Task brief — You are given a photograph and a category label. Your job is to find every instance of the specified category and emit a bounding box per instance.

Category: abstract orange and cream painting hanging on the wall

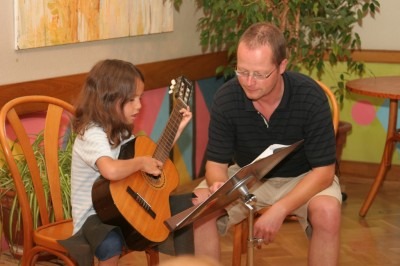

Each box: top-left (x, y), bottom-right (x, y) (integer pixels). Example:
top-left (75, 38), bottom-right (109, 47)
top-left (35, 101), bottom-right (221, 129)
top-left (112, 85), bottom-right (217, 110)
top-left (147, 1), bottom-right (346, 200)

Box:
top-left (14, 0), bottom-right (173, 50)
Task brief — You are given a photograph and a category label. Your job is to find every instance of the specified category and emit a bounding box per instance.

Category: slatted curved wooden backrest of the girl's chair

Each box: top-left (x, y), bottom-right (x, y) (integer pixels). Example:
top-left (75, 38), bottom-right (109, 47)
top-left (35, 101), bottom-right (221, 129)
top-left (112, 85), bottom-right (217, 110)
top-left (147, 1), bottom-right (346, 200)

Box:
top-left (0, 96), bottom-right (75, 254)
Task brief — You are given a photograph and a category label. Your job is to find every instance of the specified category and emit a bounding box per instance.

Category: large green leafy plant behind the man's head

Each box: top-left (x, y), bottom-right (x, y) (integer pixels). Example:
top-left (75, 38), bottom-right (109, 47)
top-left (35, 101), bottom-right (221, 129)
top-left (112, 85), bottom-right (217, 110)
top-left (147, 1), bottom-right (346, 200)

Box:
top-left (174, 0), bottom-right (380, 108)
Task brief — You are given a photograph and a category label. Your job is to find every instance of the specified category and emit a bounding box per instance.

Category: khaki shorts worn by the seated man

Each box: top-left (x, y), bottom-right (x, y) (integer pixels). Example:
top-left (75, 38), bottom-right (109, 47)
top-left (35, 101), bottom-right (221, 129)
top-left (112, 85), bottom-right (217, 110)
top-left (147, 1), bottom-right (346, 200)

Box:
top-left (197, 165), bottom-right (342, 236)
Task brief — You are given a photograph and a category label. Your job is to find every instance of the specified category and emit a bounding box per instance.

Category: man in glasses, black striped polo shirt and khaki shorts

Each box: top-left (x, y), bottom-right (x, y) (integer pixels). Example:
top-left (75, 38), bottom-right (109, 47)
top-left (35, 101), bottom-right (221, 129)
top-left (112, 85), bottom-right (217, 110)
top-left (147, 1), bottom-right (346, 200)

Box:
top-left (193, 23), bottom-right (342, 265)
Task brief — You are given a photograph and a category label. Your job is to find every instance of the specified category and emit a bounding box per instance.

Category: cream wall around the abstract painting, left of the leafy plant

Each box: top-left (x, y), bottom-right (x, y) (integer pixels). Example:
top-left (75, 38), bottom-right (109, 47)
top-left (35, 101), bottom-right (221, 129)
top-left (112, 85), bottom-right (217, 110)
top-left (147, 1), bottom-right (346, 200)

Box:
top-left (0, 0), bottom-right (201, 85)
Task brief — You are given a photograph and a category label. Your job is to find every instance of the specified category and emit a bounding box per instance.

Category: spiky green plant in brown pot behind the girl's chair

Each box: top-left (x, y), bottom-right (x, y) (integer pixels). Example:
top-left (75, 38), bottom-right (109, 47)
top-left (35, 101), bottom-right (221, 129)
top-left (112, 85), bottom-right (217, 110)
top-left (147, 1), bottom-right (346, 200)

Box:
top-left (0, 132), bottom-right (75, 257)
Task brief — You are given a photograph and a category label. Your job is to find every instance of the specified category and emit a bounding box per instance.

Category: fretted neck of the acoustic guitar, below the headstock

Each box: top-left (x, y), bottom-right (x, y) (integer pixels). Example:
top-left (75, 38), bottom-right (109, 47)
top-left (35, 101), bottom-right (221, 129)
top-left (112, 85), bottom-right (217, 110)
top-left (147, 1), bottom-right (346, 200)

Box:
top-left (153, 99), bottom-right (187, 163)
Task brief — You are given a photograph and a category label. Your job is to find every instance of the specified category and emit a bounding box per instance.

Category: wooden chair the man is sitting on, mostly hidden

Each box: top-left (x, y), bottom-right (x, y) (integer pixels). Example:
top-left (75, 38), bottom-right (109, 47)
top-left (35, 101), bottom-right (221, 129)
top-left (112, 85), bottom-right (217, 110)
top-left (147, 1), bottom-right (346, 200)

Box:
top-left (232, 81), bottom-right (340, 266)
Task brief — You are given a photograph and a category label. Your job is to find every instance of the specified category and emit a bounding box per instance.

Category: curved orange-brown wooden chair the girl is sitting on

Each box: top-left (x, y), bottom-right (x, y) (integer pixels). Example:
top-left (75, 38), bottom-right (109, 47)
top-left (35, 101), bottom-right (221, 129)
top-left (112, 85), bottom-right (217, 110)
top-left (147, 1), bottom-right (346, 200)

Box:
top-left (0, 96), bottom-right (159, 266)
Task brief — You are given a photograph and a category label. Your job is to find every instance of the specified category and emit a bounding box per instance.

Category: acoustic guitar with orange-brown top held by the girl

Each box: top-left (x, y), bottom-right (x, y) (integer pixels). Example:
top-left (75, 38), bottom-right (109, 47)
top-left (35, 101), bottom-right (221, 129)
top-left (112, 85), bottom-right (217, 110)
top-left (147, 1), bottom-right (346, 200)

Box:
top-left (92, 76), bottom-right (193, 250)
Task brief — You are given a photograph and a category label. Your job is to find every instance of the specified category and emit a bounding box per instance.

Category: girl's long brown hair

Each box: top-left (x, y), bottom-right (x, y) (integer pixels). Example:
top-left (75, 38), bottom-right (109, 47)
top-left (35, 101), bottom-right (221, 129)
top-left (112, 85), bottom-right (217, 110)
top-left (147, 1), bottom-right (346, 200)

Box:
top-left (73, 59), bottom-right (144, 147)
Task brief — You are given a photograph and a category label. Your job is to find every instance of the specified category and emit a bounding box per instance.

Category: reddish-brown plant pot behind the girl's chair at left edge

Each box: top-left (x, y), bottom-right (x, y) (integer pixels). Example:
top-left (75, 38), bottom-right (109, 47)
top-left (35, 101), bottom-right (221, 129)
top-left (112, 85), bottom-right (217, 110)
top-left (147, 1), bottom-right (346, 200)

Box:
top-left (0, 189), bottom-right (24, 259)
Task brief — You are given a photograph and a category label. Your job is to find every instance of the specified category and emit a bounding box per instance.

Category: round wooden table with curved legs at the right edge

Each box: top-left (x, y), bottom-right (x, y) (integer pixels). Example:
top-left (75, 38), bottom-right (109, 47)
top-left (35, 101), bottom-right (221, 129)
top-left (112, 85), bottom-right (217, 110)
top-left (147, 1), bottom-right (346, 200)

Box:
top-left (346, 76), bottom-right (400, 217)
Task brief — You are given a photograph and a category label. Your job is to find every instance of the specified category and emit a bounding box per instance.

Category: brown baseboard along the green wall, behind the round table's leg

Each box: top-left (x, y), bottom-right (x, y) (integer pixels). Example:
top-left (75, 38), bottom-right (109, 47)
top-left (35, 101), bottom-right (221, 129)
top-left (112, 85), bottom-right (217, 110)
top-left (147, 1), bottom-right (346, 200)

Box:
top-left (340, 160), bottom-right (400, 181)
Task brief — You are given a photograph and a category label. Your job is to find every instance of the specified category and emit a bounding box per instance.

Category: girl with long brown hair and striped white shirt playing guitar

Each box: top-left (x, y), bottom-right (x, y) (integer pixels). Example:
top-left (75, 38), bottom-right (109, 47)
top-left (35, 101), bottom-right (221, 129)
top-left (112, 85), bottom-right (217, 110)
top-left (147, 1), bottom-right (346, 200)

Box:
top-left (60, 60), bottom-right (192, 266)
